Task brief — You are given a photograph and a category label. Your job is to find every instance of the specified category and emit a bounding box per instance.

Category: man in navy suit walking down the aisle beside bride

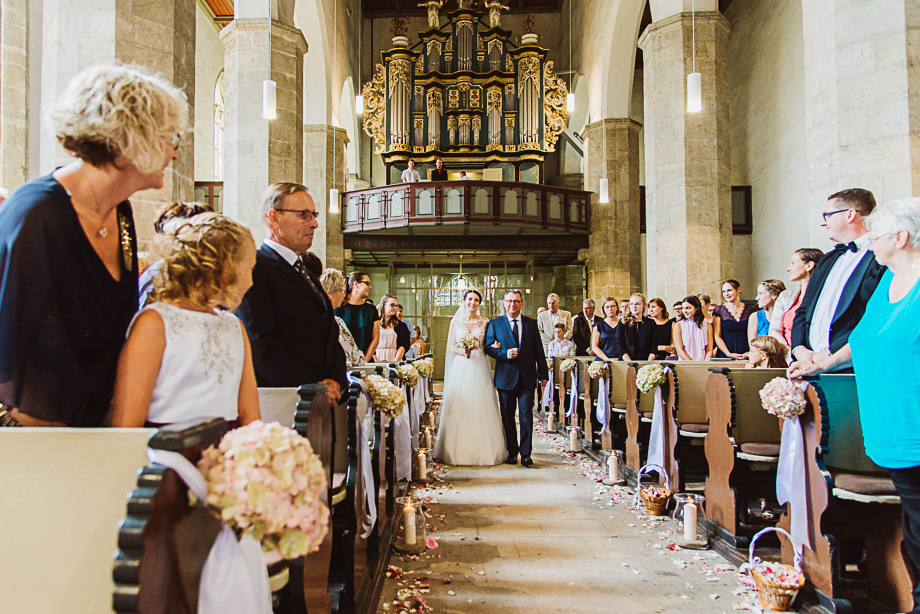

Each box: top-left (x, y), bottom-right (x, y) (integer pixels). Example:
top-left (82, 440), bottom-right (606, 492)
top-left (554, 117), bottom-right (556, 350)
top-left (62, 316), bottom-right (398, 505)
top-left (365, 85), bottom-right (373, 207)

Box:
top-left (484, 290), bottom-right (549, 467)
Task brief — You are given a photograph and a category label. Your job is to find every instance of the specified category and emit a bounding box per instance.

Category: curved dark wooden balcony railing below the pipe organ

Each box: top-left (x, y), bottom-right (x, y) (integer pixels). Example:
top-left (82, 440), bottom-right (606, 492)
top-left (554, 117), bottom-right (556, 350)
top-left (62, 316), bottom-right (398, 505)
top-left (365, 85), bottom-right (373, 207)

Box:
top-left (341, 181), bottom-right (591, 234)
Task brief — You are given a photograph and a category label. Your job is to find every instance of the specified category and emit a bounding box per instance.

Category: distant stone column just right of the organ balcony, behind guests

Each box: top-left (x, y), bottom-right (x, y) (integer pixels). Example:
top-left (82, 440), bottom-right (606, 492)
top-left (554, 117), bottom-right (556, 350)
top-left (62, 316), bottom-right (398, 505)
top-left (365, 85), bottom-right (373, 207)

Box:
top-left (573, 119), bottom-right (642, 304)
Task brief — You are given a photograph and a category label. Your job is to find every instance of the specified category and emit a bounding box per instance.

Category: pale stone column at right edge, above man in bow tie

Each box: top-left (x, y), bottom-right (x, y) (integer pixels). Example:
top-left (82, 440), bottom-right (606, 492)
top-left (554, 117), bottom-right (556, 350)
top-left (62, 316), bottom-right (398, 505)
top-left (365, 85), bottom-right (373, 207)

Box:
top-left (802, 0), bottom-right (920, 247)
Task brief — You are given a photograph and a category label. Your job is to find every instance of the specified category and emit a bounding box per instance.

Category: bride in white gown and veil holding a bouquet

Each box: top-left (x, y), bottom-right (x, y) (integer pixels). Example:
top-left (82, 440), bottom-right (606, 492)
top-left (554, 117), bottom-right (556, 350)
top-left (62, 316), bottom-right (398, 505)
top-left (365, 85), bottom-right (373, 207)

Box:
top-left (434, 290), bottom-right (508, 466)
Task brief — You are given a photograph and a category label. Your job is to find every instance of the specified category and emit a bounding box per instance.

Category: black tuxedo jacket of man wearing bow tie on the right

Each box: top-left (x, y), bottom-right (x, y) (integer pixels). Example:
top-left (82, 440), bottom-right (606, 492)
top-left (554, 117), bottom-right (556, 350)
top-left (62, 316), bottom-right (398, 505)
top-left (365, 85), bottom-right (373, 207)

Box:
top-left (792, 250), bottom-right (887, 353)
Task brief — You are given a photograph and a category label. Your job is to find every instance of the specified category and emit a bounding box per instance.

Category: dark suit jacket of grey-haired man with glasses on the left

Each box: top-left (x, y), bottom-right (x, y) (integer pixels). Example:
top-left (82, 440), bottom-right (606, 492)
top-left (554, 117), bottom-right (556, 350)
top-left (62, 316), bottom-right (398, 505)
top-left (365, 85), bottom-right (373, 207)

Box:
top-left (236, 245), bottom-right (348, 390)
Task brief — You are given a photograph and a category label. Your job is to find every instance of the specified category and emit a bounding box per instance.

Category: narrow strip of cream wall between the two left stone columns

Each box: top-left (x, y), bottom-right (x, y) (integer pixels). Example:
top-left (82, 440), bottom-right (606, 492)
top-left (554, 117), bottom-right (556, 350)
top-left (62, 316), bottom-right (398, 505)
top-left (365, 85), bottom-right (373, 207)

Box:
top-left (194, 7), bottom-right (224, 181)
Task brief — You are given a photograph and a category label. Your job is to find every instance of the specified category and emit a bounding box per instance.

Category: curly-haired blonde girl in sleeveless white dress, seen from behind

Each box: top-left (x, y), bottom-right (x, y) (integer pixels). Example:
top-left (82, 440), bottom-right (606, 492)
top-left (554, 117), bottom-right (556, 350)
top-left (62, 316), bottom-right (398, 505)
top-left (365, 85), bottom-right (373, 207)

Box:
top-left (112, 213), bottom-right (259, 427)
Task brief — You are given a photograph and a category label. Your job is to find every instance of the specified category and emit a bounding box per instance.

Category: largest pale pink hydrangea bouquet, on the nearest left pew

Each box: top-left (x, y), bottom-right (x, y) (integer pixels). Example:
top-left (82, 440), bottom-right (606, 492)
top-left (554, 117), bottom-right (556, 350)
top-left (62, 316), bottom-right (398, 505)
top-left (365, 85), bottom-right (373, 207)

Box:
top-left (198, 420), bottom-right (329, 559)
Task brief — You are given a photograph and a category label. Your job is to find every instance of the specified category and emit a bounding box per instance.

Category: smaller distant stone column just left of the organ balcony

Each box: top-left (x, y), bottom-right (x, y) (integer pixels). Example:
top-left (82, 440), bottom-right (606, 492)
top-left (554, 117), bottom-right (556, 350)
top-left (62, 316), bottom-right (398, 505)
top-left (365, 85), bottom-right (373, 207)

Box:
top-left (303, 124), bottom-right (348, 271)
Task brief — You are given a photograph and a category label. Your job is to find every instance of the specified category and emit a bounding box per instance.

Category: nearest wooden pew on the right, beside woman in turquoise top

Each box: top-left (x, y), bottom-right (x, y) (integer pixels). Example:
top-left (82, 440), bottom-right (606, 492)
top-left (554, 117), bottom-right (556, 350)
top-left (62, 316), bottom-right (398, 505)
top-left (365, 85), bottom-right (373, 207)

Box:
top-left (780, 375), bottom-right (912, 612)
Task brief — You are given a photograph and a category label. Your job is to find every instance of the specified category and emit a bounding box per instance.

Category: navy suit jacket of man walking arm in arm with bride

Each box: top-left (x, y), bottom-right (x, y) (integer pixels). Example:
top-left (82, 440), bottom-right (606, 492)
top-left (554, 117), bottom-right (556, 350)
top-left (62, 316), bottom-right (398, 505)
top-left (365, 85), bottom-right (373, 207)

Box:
top-left (484, 316), bottom-right (549, 390)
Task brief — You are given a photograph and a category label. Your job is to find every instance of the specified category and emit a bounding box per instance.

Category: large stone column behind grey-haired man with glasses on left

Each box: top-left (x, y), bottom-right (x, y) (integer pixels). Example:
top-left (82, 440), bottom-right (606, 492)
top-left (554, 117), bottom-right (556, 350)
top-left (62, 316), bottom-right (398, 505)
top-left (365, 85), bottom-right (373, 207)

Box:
top-left (220, 19), bottom-right (308, 243)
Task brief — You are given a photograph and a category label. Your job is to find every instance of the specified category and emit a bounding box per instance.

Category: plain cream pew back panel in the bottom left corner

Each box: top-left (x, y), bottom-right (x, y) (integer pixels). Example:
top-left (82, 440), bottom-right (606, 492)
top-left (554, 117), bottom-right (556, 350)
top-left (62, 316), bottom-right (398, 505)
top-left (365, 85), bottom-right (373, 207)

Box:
top-left (0, 428), bottom-right (152, 614)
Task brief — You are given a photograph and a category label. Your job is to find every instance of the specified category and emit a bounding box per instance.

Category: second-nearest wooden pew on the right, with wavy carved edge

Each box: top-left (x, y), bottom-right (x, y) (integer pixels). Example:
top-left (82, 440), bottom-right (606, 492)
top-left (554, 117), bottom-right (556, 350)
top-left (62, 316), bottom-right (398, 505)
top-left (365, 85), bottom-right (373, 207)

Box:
top-left (704, 363), bottom-right (786, 548)
